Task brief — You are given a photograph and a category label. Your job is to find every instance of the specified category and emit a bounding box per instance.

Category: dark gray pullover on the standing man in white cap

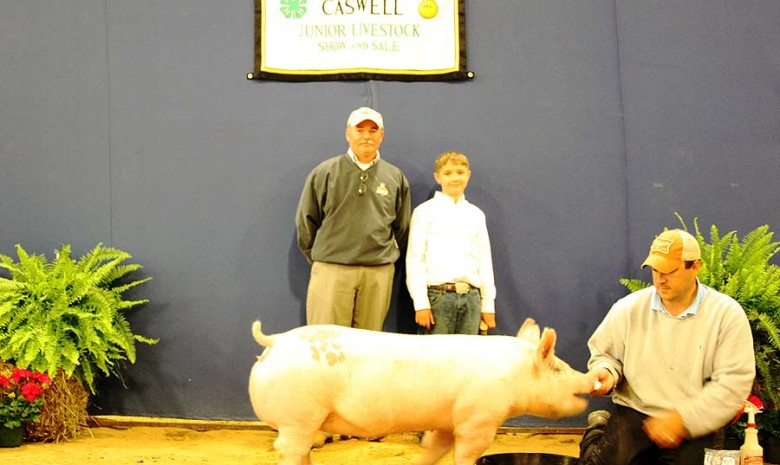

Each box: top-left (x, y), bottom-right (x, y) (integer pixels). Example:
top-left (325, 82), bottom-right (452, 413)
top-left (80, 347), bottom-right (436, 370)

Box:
top-left (295, 154), bottom-right (411, 266)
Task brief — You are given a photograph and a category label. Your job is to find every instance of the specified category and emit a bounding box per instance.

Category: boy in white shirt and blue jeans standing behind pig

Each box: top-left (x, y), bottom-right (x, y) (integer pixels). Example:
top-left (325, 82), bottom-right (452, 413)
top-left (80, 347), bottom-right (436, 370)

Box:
top-left (406, 152), bottom-right (496, 334)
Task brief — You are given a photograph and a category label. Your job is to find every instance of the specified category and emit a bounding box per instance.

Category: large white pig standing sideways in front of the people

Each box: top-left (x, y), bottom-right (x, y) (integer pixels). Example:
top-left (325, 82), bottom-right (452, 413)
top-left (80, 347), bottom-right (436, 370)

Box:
top-left (249, 318), bottom-right (596, 465)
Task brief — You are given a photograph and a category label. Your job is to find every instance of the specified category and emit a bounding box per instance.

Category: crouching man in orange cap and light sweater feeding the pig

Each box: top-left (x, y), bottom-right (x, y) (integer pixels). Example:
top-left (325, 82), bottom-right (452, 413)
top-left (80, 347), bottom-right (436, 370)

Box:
top-left (579, 229), bottom-right (755, 465)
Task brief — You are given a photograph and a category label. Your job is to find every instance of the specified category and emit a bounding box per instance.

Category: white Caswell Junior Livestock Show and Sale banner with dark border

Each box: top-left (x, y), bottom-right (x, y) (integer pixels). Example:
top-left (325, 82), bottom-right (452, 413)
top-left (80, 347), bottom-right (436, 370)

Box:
top-left (247, 0), bottom-right (474, 81)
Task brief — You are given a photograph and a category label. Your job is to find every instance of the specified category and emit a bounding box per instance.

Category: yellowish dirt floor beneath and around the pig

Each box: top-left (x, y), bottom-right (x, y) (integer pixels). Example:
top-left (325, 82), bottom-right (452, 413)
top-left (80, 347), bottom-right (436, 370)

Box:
top-left (0, 418), bottom-right (580, 465)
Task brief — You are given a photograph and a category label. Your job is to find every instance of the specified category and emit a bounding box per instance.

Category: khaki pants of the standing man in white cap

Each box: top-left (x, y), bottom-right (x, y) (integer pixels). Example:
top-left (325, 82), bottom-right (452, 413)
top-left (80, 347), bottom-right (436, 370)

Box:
top-left (306, 262), bottom-right (395, 331)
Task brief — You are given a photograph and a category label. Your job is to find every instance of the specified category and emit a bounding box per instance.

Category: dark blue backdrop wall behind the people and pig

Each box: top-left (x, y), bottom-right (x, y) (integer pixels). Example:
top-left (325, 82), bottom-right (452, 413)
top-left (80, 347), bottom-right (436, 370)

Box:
top-left (0, 0), bottom-right (780, 426)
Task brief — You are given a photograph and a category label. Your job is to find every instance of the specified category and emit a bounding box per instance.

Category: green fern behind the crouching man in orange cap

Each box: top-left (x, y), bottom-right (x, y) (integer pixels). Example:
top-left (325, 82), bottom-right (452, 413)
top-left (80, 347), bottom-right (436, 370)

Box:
top-left (620, 214), bottom-right (780, 463)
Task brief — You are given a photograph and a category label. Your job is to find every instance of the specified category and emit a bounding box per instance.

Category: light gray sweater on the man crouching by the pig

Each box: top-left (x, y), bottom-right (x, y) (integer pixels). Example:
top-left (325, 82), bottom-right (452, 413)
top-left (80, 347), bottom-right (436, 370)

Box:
top-left (588, 283), bottom-right (755, 437)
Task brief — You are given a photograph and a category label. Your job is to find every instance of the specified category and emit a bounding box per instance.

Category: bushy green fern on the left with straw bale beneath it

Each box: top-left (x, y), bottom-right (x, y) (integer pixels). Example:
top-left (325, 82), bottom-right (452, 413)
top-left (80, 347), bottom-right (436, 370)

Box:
top-left (0, 244), bottom-right (157, 441)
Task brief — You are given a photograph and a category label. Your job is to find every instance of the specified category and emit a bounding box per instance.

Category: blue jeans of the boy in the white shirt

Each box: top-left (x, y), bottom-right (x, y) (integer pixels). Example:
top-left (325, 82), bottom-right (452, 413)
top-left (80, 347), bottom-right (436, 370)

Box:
top-left (418, 289), bottom-right (482, 335)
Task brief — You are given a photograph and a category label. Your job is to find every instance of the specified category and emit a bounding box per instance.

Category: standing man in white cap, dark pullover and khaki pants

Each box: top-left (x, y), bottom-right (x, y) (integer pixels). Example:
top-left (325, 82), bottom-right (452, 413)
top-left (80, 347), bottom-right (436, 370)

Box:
top-left (295, 107), bottom-right (411, 331)
